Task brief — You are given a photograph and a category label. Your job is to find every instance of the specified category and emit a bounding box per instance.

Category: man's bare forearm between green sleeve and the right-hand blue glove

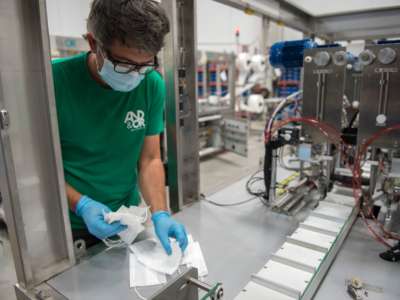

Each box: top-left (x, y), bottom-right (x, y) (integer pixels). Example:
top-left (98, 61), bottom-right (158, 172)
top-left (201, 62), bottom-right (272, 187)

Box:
top-left (140, 158), bottom-right (168, 212)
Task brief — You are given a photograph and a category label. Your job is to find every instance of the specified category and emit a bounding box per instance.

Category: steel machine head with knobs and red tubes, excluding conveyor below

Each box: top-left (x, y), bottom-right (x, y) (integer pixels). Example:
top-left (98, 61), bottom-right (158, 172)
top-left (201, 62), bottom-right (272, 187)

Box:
top-left (264, 41), bottom-right (400, 233)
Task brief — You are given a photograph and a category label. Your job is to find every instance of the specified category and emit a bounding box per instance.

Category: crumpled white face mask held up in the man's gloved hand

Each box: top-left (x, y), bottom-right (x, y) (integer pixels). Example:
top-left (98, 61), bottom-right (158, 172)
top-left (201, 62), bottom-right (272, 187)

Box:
top-left (103, 206), bottom-right (149, 247)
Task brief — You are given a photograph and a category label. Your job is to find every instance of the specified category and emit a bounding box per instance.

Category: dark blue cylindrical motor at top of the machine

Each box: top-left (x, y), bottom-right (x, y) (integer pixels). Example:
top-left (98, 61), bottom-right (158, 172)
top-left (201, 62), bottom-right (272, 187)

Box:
top-left (269, 39), bottom-right (317, 68)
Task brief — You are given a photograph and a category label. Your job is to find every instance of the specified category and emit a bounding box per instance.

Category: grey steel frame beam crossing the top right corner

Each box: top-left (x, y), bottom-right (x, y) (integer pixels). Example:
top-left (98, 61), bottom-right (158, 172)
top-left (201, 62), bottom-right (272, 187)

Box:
top-left (214, 0), bottom-right (400, 41)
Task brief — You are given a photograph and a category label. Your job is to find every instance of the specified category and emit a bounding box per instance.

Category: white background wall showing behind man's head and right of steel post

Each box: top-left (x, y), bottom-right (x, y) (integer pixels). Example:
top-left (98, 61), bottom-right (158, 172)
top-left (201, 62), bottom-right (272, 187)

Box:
top-left (47, 0), bottom-right (302, 52)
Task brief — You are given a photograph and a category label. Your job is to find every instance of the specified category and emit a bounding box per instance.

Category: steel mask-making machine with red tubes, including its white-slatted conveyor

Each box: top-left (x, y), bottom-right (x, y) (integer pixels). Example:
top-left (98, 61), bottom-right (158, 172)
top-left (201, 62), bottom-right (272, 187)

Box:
top-left (244, 41), bottom-right (400, 299)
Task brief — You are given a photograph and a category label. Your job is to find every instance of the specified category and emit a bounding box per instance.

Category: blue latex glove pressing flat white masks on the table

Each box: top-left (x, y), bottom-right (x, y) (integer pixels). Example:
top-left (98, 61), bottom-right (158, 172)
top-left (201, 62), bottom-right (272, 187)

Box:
top-left (151, 211), bottom-right (188, 255)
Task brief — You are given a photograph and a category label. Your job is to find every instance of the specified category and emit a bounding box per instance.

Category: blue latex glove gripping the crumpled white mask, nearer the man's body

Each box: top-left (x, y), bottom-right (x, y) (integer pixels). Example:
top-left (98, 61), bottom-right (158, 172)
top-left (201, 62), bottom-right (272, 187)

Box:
top-left (75, 196), bottom-right (127, 240)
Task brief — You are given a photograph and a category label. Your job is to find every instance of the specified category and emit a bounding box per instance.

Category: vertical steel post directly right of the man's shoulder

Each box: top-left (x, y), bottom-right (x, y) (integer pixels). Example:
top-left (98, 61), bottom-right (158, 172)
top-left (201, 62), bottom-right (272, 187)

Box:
top-left (162, 0), bottom-right (199, 211)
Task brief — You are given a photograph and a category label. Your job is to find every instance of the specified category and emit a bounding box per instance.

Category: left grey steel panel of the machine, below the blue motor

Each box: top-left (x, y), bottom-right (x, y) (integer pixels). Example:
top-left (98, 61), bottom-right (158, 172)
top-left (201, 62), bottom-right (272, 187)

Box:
top-left (303, 47), bottom-right (346, 142)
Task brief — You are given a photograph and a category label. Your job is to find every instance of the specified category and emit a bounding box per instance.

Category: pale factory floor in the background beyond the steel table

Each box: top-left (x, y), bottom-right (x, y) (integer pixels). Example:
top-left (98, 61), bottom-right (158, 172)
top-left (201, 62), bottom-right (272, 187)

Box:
top-left (0, 121), bottom-right (264, 300)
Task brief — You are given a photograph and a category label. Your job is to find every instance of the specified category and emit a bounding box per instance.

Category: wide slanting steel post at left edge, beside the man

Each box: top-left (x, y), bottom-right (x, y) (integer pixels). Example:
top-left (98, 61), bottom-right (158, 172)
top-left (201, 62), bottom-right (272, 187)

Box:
top-left (0, 0), bottom-right (74, 289)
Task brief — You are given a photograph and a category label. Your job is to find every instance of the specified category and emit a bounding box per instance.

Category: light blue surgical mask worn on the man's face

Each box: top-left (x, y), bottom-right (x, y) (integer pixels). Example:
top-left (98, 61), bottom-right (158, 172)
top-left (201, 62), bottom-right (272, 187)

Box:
top-left (99, 58), bottom-right (144, 92)
